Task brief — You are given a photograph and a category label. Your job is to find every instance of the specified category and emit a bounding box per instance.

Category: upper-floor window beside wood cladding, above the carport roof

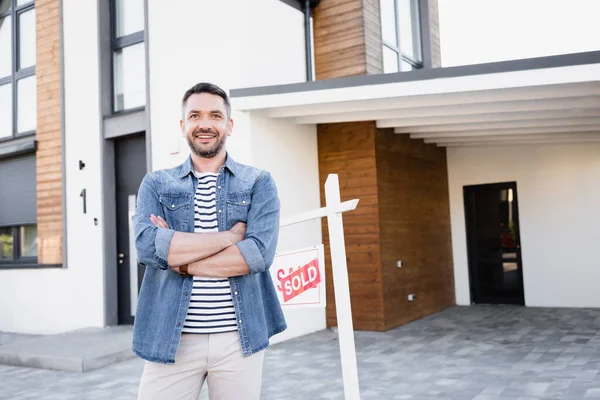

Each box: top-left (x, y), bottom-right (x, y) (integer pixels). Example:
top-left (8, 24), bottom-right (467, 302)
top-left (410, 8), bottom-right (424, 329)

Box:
top-left (379, 0), bottom-right (423, 73)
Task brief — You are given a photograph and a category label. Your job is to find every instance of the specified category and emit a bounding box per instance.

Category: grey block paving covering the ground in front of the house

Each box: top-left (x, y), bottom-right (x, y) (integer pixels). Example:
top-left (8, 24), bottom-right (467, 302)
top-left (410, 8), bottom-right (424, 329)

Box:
top-left (0, 306), bottom-right (600, 400)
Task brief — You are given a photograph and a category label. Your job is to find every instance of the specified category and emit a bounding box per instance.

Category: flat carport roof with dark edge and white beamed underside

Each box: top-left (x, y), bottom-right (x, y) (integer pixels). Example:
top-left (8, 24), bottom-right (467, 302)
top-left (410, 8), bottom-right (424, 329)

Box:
top-left (231, 51), bottom-right (600, 146)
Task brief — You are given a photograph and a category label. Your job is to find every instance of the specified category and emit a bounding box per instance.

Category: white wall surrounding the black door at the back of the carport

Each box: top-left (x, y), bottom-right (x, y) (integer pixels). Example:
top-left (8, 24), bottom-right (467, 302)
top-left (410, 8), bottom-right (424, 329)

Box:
top-left (448, 143), bottom-right (600, 307)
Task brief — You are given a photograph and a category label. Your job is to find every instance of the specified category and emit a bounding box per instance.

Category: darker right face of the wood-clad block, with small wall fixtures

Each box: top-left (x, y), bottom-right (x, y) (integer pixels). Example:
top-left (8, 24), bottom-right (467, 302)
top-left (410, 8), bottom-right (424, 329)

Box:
top-left (375, 129), bottom-right (455, 329)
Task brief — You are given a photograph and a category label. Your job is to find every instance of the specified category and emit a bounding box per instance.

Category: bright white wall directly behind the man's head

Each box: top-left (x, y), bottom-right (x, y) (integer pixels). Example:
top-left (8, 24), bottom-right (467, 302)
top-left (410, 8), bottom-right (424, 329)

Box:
top-left (148, 0), bottom-right (305, 169)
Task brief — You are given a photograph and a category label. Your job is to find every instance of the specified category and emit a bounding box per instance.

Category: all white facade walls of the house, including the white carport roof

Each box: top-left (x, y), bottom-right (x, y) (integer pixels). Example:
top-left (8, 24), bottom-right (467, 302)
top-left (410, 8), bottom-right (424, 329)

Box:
top-left (0, 0), bottom-right (600, 342)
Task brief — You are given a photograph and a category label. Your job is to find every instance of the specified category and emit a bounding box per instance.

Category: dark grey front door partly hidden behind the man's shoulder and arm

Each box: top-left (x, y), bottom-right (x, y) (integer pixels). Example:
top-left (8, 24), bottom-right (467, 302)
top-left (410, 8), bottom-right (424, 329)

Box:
top-left (114, 133), bottom-right (146, 324)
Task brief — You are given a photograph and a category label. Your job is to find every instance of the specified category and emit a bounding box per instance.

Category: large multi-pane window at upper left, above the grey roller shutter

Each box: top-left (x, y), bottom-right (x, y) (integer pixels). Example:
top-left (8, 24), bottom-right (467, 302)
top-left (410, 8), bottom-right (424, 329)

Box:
top-left (0, 0), bottom-right (36, 141)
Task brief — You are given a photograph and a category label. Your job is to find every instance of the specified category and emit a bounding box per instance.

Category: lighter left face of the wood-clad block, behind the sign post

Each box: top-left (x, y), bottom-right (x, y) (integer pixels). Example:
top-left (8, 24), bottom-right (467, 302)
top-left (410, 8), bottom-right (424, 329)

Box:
top-left (317, 122), bottom-right (384, 330)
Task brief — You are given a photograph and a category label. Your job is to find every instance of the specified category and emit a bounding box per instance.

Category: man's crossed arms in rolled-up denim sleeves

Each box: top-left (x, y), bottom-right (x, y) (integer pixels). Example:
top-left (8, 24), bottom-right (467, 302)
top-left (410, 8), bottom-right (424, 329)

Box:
top-left (132, 173), bottom-right (279, 278)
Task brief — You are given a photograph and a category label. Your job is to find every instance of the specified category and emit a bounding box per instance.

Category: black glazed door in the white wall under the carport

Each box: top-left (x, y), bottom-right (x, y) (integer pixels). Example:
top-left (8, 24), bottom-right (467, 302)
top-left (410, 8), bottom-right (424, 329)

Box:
top-left (464, 182), bottom-right (525, 305)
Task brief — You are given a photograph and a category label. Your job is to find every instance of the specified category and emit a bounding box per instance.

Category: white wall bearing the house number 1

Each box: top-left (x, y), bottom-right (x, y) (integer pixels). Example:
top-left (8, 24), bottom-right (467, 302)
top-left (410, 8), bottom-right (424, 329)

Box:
top-left (0, 0), bottom-right (104, 334)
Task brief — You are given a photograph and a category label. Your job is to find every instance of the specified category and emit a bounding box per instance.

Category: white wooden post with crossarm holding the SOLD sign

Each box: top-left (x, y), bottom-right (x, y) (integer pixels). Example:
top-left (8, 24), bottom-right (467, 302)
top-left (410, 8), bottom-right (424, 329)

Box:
top-left (280, 174), bottom-right (360, 400)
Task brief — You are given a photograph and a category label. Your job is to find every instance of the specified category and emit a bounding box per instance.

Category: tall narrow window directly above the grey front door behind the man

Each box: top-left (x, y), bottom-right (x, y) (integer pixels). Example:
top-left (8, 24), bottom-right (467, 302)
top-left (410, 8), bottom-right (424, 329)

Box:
top-left (111, 0), bottom-right (146, 112)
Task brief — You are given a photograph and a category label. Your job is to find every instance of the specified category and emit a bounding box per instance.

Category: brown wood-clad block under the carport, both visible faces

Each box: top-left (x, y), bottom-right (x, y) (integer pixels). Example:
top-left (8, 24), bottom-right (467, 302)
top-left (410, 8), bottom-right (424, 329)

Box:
top-left (317, 122), bottom-right (454, 330)
